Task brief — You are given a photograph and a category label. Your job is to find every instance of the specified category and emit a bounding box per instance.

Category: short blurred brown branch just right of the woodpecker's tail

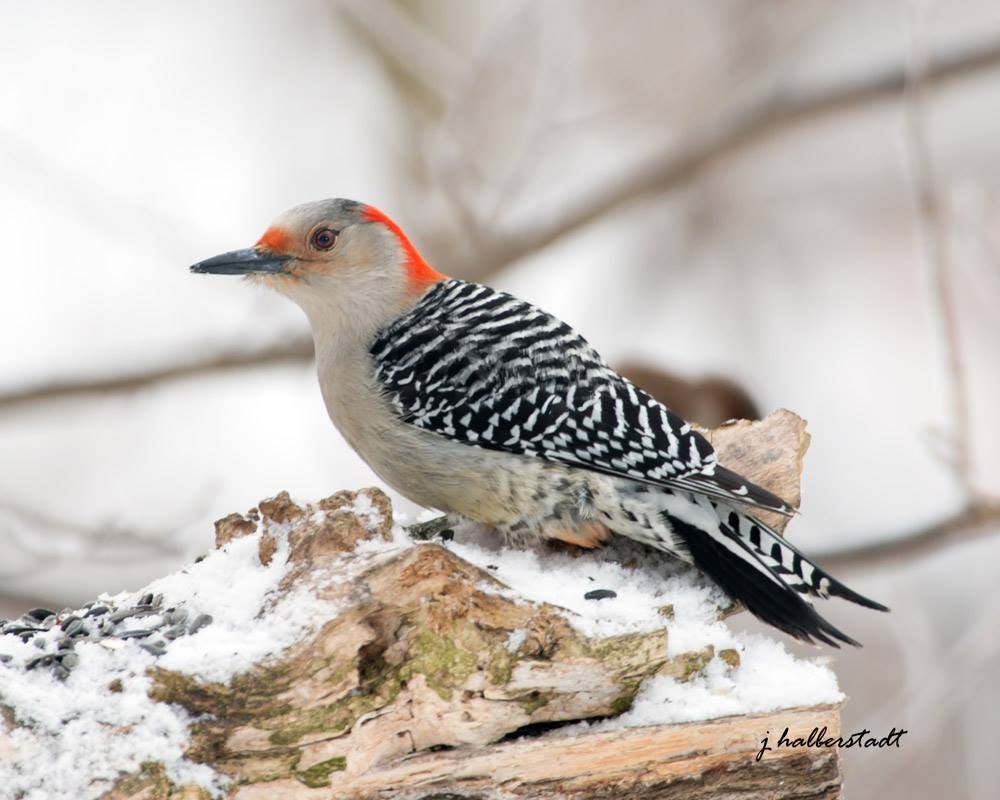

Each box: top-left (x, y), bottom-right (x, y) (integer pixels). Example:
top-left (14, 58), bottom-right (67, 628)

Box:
top-left (815, 499), bottom-right (1000, 571)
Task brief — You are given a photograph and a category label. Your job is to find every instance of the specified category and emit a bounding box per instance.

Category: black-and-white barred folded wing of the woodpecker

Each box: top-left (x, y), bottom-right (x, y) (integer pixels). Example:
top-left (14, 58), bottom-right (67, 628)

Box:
top-left (371, 280), bottom-right (792, 513)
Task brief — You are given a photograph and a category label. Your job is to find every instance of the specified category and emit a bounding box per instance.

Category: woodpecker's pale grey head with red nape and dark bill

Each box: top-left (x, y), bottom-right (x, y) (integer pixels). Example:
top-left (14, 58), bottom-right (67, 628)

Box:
top-left (191, 199), bottom-right (445, 334)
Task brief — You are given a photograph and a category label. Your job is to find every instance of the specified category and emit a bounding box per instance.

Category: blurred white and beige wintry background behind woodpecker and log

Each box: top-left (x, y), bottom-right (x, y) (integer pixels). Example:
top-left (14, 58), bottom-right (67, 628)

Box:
top-left (0, 0), bottom-right (1000, 798)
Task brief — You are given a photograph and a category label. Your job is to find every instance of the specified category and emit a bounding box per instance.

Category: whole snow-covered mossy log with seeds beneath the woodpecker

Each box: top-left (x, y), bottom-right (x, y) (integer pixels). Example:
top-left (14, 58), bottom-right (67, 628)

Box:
top-left (0, 411), bottom-right (842, 800)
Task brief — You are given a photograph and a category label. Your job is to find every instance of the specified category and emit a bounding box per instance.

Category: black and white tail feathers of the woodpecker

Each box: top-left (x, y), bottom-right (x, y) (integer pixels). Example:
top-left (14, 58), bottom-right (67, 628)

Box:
top-left (664, 500), bottom-right (889, 647)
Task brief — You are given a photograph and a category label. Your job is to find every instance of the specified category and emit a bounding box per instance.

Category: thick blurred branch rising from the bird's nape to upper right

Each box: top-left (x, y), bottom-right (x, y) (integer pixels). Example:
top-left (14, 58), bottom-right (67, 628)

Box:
top-left (445, 35), bottom-right (1000, 280)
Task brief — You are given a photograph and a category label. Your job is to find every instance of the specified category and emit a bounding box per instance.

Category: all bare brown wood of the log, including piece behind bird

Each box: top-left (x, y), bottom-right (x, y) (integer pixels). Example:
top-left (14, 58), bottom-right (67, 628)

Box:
top-left (0, 412), bottom-right (840, 800)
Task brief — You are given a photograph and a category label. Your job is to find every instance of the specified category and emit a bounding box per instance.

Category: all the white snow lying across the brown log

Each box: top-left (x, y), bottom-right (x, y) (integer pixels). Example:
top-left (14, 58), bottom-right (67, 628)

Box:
top-left (0, 506), bottom-right (843, 800)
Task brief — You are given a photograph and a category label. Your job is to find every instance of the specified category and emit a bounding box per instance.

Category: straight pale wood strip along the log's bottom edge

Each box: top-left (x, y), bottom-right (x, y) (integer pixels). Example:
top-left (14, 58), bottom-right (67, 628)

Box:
top-left (107, 706), bottom-right (842, 800)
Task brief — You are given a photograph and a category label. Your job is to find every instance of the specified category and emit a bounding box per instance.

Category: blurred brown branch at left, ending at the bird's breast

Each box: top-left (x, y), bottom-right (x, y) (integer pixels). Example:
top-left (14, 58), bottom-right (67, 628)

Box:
top-left (0, 336), bottom-right (313, 412)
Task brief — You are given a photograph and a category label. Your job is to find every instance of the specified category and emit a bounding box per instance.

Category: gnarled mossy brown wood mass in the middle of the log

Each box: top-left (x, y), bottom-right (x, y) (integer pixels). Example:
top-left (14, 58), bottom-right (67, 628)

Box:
top-left (153, 491), bottom-right (710, 797)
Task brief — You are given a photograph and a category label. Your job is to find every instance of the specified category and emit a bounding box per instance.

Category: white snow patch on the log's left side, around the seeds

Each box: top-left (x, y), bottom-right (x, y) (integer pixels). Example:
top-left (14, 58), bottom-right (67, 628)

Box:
top-left (0, 510), bottom-right (349, 800)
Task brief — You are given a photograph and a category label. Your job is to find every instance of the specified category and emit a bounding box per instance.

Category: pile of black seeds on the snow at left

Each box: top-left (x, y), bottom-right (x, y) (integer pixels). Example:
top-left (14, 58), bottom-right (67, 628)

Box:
top-left (0, 594), bottom-right (212, 680)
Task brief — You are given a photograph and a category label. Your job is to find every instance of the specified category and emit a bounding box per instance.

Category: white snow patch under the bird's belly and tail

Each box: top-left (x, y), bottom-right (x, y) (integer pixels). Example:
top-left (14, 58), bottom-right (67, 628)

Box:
top-left (441, 525), bottom-right (844, 724)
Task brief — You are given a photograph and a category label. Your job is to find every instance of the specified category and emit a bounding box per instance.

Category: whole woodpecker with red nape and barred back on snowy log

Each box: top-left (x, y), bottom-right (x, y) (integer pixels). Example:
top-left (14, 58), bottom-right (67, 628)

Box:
top-left (191, 199), bottom-right (888, 647)
